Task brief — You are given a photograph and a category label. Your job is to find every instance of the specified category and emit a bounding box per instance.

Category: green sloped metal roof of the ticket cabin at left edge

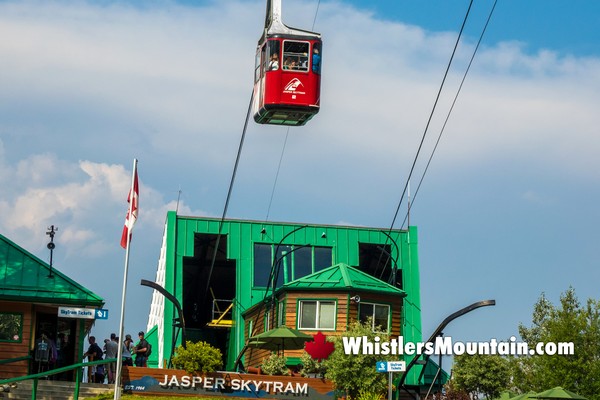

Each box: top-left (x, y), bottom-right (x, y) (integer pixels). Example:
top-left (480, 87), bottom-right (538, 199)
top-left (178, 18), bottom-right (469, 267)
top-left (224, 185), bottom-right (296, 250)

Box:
top-left (0, 235), bottom-right (104, 307)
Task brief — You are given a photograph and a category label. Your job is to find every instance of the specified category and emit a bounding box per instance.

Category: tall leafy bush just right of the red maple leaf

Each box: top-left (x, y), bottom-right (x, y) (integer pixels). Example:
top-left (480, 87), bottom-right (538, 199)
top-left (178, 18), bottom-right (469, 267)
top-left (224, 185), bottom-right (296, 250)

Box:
top-left (323, 320), bottom-right (391, 399)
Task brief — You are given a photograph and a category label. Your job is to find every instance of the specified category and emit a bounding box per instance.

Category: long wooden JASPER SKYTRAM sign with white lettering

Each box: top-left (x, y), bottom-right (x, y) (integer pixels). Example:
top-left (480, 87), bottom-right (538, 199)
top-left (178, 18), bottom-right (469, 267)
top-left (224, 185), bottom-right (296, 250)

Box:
top-left (122, 367), bottom-right (334, 400)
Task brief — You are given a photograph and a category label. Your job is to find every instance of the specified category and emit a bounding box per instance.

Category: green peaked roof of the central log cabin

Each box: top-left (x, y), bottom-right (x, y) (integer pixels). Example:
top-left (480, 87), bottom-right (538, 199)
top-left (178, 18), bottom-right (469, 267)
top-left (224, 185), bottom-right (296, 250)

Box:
top-left (283, 263), bottom-right (406, 296)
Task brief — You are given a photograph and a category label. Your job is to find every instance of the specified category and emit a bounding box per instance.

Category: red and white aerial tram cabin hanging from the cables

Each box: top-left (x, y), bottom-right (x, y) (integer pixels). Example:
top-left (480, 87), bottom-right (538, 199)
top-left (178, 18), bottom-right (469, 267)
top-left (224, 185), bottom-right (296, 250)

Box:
top-left (252, 0), bottom-right (322, 126)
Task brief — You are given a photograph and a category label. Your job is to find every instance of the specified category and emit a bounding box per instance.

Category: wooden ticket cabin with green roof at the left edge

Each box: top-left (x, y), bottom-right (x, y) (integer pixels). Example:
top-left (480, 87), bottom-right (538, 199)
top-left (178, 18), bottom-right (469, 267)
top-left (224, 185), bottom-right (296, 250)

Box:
top-left (0, 235), bottom-right (104, 380)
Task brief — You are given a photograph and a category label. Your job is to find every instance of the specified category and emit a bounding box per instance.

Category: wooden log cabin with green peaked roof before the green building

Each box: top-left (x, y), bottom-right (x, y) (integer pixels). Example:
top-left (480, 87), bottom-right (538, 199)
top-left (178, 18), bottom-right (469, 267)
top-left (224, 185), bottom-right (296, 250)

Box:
top-left (242, 263), bottom-right (406, 370)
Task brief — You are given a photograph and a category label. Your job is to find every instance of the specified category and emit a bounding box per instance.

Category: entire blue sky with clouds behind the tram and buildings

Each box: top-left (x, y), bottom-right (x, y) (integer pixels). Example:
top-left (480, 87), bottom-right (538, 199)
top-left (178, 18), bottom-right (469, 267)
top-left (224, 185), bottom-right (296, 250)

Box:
top-left (0, 0), bottom-right (600, 368)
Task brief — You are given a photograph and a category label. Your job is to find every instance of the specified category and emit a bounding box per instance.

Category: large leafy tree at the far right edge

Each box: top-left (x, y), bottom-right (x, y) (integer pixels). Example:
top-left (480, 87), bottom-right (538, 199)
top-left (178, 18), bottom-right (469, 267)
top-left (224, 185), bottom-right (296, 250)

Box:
top-left (511, 288), bottom-right (600, 400)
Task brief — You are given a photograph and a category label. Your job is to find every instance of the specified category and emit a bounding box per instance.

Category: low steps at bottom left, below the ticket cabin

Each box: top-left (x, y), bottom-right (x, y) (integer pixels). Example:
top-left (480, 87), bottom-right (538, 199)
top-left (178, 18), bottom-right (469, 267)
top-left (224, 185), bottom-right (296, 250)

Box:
top-left (0, 379), bottom-right (115, 400)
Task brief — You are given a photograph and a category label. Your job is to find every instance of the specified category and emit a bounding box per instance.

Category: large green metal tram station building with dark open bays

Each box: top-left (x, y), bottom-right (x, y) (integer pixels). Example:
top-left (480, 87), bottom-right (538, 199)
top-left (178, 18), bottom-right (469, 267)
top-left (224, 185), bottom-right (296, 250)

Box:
top-left (146, 212), bottom-right (422, 384)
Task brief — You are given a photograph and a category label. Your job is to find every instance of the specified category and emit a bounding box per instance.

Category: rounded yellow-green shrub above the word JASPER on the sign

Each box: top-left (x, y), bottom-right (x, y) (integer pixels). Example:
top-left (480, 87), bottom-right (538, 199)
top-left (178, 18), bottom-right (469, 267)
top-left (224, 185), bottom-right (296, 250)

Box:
top-left (172, 341), bottom-right (223, 374)
